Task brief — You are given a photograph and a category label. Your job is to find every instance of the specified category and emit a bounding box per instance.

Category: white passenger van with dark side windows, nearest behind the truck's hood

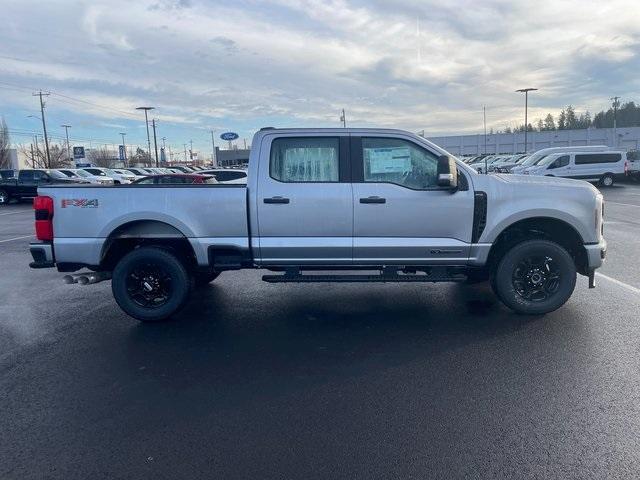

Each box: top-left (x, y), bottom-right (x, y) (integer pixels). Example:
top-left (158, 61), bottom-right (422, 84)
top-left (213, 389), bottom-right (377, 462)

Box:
top-left (522, 150), bottom-right (627, 187)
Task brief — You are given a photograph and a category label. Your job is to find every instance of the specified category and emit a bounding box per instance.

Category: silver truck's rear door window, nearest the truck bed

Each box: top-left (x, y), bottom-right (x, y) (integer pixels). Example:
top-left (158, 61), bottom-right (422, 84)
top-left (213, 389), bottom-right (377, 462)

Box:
top-left (269, 137), bottom-right (339, 182)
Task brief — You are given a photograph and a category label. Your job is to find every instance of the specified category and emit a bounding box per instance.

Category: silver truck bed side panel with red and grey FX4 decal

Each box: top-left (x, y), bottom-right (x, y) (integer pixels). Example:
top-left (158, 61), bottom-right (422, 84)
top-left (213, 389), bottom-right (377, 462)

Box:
top-left (38, 184), bottom-right (249, 265)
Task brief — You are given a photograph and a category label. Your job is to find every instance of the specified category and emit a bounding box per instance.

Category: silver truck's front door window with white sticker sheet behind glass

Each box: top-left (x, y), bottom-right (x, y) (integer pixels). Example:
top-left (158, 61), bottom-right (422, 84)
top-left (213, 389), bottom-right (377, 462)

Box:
top-left (362, 138), bottom-right (438, 190)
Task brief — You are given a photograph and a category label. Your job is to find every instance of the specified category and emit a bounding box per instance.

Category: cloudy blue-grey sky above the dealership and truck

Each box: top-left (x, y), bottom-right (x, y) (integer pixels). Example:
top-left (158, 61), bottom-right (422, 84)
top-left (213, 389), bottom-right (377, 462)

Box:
top-left (0, 0), bottom-right (640, 156)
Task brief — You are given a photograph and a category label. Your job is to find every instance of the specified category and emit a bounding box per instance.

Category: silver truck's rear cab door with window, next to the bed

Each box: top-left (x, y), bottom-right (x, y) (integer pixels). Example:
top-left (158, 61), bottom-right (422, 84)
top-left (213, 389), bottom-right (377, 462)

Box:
top-left (254, 134), bottom-right (353, 265)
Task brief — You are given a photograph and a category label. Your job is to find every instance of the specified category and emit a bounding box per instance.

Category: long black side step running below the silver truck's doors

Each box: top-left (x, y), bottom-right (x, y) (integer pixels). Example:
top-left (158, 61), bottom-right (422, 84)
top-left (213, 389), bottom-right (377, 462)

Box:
top-left (262, 268), bottom-right (467, 283)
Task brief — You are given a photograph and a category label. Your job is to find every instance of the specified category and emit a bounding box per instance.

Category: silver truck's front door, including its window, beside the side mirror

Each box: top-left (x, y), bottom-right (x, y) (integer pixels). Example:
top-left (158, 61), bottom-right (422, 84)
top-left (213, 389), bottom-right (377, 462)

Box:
top-left (351, 134), bottom-right (473, 265)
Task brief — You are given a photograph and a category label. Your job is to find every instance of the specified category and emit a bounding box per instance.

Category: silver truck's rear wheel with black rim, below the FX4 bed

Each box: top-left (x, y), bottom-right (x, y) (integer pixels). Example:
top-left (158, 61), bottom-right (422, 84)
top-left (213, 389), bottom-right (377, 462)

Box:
top-left (111, 247), bottom-right (192, 322)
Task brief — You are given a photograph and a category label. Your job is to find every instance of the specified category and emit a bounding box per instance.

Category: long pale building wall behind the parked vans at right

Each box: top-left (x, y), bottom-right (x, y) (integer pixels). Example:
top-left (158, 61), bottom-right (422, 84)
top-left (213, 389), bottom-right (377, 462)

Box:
top-left (427, 127), bottom-right (640, 155)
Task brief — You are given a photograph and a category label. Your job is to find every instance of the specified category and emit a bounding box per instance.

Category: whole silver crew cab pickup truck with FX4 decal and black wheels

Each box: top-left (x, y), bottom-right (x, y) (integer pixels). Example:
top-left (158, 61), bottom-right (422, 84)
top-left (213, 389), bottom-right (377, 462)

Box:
top-left (31, 128), bottom-right (606, 321)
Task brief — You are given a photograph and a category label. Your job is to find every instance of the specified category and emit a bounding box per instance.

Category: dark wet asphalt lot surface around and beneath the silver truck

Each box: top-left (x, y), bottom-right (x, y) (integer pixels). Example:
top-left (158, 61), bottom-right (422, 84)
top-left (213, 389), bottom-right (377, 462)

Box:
top-left (0, 185), bottom-right (640, 478)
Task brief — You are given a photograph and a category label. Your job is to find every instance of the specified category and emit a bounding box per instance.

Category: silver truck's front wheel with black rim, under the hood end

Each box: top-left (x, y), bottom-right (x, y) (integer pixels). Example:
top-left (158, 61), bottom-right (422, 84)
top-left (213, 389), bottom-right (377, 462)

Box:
top-left (491, 240), bottom-right (576, 315)
